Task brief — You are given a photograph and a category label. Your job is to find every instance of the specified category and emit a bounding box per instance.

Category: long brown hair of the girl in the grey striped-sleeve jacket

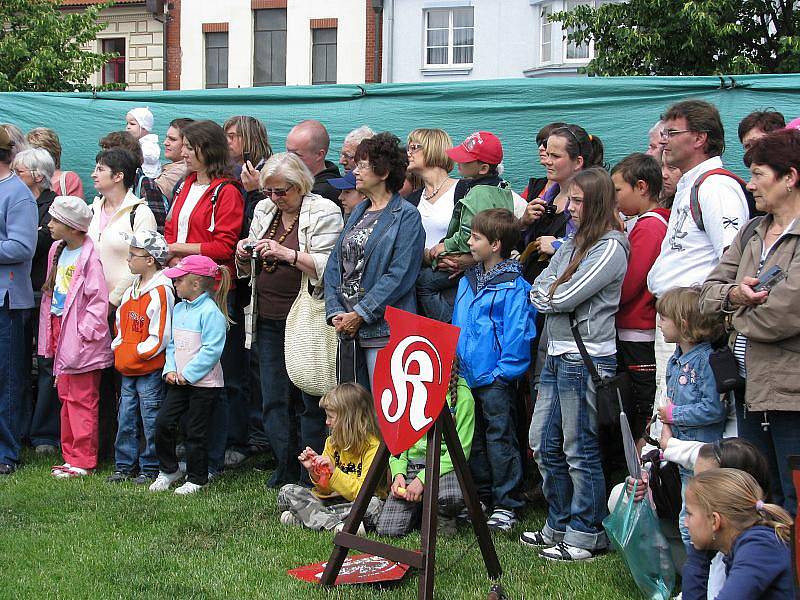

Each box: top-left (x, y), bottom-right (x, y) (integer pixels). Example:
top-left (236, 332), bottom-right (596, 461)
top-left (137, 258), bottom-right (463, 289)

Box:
top-left (550, 167), bottom-right (622, 299)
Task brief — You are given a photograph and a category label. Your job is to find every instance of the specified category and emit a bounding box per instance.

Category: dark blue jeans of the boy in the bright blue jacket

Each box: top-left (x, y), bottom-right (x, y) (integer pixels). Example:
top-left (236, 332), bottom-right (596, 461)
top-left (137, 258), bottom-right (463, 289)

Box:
top-left (469, 379), bottom-right (523, 510)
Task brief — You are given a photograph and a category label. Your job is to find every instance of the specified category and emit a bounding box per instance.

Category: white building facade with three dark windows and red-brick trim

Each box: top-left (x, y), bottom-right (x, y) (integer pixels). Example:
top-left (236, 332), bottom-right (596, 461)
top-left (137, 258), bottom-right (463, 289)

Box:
top-left (180, 0), bottom-right (367, 89)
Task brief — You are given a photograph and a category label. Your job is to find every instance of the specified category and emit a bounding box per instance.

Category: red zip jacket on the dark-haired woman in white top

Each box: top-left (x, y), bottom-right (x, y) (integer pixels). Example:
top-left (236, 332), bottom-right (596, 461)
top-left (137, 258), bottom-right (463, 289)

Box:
top-left (164, 173), bottom-right (244, 281)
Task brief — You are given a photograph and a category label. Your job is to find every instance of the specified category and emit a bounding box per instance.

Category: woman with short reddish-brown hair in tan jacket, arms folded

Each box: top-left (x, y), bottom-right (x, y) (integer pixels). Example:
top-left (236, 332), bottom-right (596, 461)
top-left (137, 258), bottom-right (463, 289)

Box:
top-left (700, 129), bottom-right (800, 514)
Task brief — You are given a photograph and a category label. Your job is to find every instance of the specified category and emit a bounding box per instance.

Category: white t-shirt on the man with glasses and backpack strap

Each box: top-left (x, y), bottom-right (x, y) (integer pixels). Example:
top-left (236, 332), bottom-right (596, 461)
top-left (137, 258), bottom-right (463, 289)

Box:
top-left (647, 156), bottom-right (749, 296)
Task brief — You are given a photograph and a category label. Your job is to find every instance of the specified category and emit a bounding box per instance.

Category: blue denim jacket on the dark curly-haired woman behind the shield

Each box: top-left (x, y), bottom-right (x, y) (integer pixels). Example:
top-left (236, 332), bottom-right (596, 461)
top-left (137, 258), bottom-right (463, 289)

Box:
top-left (323, 194), bottom-right (425, 339)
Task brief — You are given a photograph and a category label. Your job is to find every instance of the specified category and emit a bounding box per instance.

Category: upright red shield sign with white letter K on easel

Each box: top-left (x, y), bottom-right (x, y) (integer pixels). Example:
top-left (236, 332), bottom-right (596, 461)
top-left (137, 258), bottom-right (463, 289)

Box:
top-left (372, 306), bottom-right (459, 455)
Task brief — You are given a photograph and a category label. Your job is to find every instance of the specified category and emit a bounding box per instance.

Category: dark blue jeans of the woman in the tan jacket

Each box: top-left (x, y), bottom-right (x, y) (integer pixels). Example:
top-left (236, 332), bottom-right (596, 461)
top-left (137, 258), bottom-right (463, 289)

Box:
top-left (736, 392), bottom-right (800, 517)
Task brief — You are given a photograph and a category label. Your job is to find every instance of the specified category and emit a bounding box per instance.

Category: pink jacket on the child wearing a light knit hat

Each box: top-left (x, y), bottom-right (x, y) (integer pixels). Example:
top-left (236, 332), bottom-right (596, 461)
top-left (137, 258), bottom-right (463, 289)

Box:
top-left (39, 235), bottom-right (114, 377)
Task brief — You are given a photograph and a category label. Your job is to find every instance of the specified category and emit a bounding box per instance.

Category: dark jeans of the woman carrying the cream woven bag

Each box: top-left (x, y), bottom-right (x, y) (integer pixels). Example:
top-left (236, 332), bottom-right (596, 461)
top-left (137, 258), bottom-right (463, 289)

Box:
top-left (256, 318), bottom-right (325, 488)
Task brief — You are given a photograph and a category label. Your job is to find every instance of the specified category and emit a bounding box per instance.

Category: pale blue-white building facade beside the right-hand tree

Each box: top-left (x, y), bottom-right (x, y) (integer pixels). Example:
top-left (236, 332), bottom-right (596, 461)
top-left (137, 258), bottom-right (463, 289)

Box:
top-left (383, 0), bottom-right (607, 82)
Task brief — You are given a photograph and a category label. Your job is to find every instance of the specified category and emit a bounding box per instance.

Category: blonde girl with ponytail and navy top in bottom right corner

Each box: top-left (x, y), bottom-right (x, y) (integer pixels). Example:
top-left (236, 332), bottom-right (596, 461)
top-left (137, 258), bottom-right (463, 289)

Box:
top-left (686, 469), bottom-right (795, 600)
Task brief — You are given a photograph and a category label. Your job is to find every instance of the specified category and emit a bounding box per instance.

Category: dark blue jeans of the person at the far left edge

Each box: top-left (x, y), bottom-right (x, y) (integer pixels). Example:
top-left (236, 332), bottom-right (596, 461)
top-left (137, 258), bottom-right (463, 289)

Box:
top-left (0, 295), bottom-right (29, 465)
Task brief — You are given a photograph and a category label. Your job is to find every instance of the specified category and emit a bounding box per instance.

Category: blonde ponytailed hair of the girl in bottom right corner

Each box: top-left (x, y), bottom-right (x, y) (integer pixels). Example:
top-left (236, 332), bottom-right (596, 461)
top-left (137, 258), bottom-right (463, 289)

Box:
top-left (687, 468), bottom-right (792, 543)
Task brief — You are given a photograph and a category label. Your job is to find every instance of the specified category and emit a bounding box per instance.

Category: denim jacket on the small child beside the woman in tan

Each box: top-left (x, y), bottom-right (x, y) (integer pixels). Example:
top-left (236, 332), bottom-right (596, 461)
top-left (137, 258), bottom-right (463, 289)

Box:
top-left (667, 342), bottom-right (728, 442)
